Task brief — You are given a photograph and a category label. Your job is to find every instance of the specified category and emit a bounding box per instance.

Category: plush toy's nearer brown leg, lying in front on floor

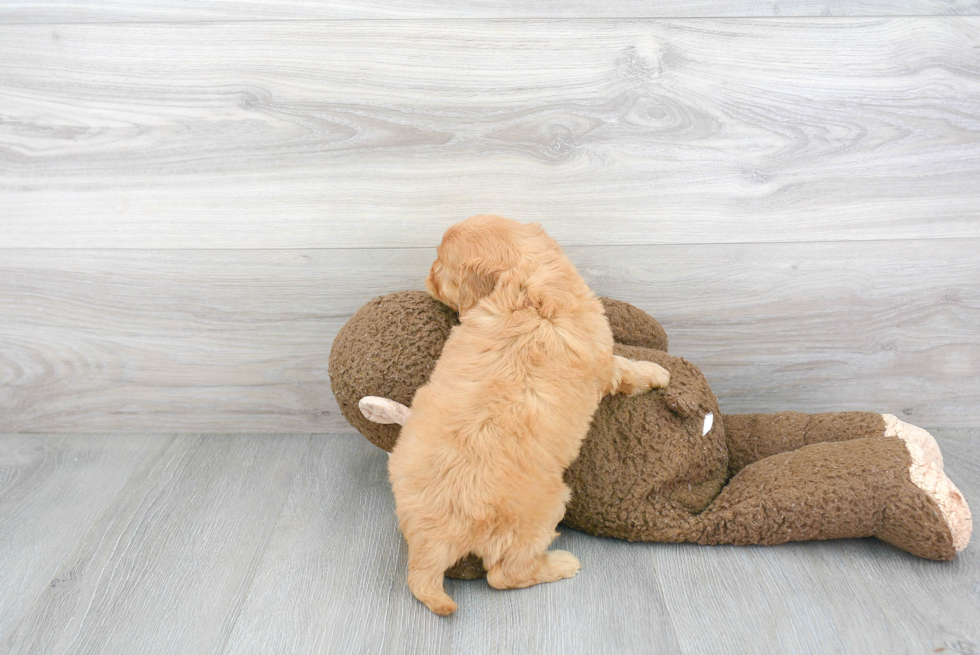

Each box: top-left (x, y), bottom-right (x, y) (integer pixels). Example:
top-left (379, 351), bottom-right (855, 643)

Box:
top-left (695, 437), bottom-right (970, 560)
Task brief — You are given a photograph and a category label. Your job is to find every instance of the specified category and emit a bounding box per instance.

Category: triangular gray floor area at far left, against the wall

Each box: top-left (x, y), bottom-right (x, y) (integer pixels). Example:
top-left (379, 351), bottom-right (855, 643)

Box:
top-left (0, 434), bottom-right (169, 636)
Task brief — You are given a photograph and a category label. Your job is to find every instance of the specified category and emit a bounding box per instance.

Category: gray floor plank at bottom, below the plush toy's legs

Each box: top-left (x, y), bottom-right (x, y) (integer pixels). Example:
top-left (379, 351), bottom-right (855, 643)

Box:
top-left (651, 542), bottom-right (902, 655)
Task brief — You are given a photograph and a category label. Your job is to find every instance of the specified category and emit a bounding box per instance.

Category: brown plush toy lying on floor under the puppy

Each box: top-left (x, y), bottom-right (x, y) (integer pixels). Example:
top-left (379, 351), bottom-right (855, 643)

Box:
top-left (329, 291), bottom-right (972, 578)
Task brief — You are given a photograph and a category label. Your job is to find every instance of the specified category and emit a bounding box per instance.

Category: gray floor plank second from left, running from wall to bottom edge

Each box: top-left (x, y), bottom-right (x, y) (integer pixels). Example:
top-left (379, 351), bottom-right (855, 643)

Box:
top-left (0, 435), bottom-right (309, 653)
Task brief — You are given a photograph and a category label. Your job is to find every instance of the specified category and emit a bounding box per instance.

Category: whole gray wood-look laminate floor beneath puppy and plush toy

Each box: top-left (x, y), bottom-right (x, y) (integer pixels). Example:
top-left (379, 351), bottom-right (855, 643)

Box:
top-left (0, 430), bottom-right (980, 654)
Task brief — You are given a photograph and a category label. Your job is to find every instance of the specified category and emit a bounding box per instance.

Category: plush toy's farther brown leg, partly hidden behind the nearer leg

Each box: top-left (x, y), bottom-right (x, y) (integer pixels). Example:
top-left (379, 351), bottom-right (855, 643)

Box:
top-left (722, 412), bottom-right (886, 475)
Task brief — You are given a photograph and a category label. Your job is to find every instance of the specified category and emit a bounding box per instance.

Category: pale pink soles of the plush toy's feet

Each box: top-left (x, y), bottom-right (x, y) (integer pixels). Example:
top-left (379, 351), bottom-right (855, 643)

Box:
top-left (882, 414), bottom-right (973, 552)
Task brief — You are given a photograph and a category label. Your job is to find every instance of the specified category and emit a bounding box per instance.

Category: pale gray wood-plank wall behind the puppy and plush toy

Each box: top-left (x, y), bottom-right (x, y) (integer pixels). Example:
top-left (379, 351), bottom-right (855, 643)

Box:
top-left (0, 0), bottom-right (980, 432)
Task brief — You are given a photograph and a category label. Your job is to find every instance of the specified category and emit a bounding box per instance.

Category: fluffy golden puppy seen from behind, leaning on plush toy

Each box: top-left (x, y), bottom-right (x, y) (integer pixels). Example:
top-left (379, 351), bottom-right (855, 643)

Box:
top-left (388, 215), bottom-right (670, 615)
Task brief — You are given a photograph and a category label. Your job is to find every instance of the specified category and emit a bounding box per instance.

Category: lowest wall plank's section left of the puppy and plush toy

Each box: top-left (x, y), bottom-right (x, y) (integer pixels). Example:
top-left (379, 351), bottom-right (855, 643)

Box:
top-left (0, 250), bottom-right (384, 432)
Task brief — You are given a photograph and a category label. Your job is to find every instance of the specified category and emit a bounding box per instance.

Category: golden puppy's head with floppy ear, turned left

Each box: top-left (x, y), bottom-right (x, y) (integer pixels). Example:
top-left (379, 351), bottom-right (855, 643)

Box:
top-left (425, 214), bottom-right (544, 313)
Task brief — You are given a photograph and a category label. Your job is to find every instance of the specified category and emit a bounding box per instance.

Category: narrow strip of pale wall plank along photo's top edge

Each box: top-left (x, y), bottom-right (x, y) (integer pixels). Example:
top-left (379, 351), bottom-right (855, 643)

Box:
top-left (0, 0), bottom-right (980, 24)
